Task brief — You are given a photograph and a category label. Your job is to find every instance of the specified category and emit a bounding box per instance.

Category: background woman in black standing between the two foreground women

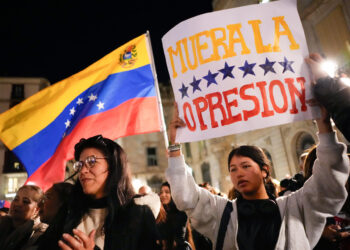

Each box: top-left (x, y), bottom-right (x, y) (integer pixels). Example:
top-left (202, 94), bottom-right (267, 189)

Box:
top-left (158, 182), bottom-right (195, 250)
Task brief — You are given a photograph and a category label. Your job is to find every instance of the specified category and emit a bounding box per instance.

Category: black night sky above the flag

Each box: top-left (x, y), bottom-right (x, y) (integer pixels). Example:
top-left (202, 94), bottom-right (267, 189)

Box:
top-left (0, 0), bottom-right (212, 84)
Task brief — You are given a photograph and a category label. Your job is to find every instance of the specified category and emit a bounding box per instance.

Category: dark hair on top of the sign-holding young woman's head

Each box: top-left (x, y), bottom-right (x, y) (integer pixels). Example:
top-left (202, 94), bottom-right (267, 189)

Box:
top-left (227, 145), bottom-right (270, 178)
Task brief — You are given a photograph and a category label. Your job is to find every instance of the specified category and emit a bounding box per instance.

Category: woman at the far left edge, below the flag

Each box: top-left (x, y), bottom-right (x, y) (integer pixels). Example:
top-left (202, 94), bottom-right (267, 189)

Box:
top-left (0, 185), bottom-right (47, 250)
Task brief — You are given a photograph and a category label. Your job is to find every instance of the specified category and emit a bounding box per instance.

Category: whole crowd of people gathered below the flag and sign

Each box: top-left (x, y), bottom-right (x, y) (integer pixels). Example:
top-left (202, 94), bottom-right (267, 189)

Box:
top-left (0, 54), bottom-right (350, 250)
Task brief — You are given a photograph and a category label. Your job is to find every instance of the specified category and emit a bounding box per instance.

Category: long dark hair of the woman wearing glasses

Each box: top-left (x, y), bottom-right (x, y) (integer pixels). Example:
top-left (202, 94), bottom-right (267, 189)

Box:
top-left (66, 135), bottom-right (135, 232)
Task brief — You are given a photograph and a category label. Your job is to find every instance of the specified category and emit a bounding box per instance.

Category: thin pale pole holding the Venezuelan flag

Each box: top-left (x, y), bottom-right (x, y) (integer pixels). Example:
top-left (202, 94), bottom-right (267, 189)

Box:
top-left (146, 30), bottom-right (169, 147)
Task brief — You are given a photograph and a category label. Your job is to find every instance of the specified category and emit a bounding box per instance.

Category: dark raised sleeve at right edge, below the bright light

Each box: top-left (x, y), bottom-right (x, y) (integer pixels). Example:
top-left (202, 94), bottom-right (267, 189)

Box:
top-left (314, 77), bottom-right (350, 141)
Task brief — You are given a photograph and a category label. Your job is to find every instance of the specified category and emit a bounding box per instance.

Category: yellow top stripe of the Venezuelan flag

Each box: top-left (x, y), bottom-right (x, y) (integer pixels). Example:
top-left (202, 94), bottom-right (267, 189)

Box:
top-left (0, 35), bottom-right (150, 150)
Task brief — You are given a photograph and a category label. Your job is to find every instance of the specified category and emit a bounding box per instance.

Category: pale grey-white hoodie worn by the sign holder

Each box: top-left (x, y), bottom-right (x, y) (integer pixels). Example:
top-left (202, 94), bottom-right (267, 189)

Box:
top-left (166, 132), bottom-right (349, 250)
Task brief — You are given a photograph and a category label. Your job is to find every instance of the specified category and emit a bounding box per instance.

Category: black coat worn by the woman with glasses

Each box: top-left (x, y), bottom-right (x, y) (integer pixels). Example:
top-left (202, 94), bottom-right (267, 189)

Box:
top-left (39, 200), bottom-right (159, 250)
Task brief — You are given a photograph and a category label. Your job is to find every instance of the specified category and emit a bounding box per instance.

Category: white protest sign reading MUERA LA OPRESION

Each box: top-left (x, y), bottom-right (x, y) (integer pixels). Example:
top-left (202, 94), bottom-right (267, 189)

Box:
top-left (162, 0), bottom-right (318, 142)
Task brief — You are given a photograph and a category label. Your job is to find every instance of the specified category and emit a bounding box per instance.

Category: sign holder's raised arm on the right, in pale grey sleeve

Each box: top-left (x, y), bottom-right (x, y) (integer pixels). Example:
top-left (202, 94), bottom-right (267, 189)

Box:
top-left (291, 54), bottom-right (349, 247)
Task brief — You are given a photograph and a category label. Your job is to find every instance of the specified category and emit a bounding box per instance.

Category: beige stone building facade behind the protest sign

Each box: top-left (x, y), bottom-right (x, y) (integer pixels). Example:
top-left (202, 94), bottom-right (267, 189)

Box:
top-left (123, 0), bottom-right (350, 193)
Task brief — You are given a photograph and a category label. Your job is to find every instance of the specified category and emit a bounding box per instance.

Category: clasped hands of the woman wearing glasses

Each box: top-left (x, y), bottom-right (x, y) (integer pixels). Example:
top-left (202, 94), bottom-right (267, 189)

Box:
top-left (58, 229), bottom-right (96, 250)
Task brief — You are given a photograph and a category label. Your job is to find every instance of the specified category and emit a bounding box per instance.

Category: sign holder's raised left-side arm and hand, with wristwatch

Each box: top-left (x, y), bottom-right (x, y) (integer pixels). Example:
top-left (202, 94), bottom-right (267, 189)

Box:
top-left (166, 104), bottom-right (227, 245)
